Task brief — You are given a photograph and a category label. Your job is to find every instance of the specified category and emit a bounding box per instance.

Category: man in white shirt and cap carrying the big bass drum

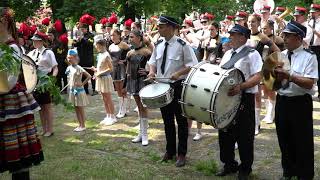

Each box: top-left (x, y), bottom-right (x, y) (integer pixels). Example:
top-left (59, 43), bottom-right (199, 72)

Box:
top-left (216, 24), bottom-right (262, 179)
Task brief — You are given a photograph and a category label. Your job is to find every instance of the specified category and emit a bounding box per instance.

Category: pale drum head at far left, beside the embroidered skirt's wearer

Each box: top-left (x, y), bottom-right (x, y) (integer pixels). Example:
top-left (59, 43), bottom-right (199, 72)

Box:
top-left (22, 55), bottom-right (38, 93)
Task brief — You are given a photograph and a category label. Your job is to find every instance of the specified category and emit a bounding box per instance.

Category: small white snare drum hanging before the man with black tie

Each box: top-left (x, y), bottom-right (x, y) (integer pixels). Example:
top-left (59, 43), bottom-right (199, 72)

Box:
top-left (139, 83), bottom-right (174, 109)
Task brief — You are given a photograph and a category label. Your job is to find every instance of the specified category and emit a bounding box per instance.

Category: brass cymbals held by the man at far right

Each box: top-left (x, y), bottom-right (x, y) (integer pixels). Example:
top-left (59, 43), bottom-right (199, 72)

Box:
top-left (261, 52), bottom-right (290, 91)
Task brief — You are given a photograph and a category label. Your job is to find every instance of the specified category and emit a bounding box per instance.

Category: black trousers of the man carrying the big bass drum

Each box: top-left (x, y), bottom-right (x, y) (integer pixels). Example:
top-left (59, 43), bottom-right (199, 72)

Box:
top-left (219, 93), bottom-right (255, 174)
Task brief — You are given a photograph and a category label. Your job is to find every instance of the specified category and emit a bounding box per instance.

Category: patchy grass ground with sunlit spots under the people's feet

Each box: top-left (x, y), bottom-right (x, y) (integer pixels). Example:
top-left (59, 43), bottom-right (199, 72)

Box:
top-left (0, 93), bottom-right (320, 180)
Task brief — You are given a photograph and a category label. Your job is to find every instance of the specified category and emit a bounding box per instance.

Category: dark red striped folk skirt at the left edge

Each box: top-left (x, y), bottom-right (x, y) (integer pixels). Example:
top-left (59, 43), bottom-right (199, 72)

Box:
top-left (0, 85), bottom-right (43, 172)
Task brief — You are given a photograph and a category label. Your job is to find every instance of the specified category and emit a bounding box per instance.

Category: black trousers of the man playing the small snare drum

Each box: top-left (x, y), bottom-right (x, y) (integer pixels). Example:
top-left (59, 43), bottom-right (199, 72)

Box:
top-left (160, 81), bottom-right (188, 156)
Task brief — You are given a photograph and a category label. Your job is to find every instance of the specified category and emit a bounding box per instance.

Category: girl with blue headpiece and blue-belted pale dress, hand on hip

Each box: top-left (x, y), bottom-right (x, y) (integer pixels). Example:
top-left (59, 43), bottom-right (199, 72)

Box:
top-left (66, 49), bottom-right (91, 132)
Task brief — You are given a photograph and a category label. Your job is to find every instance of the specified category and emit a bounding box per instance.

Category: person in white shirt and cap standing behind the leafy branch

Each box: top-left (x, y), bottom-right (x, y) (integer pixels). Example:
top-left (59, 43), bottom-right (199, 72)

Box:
top-left (28, 31), bottom-right (58, 137)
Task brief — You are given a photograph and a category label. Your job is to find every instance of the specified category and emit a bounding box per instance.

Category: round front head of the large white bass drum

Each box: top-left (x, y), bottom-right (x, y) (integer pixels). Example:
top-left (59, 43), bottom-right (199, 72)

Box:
top-left (213, 69), bottom-right (244, 129)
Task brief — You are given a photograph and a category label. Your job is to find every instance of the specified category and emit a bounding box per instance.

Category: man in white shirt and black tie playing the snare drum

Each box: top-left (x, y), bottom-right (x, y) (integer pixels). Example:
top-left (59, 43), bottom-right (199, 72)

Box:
top-left (148, 16), bottom-right (198, 167)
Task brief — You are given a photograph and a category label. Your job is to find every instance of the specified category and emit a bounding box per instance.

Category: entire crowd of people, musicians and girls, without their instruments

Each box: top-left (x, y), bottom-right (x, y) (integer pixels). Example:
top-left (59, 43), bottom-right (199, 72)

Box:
top-left (0, 0), bottom-right (320, 180)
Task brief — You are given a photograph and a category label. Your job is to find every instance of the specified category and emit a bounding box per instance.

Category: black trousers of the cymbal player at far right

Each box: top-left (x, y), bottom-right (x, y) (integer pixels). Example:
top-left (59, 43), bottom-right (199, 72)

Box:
top-left (275, 95), bottom-right (314, 179)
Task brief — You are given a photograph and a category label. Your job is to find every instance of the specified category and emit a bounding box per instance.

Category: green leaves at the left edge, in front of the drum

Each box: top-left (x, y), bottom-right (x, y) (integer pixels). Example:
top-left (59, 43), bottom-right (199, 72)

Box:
top-left (0, 44), bottom-right (21, 76)
